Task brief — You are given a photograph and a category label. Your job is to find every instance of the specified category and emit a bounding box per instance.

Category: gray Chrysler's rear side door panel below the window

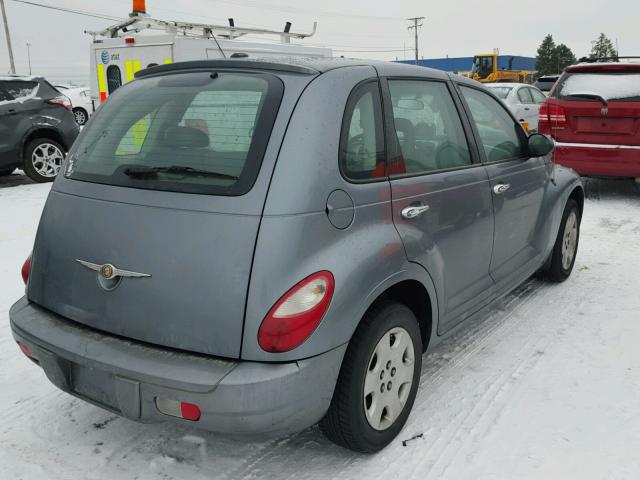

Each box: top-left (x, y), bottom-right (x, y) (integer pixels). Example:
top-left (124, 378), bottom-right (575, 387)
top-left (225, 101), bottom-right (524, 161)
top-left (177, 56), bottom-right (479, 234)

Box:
top-left (391, 165), bottom-right (494, 333)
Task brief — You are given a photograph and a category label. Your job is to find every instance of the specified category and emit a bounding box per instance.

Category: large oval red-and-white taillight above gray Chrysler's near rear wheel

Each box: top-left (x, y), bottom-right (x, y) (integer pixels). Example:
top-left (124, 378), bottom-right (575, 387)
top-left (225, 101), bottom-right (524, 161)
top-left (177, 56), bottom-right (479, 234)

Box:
top-left (258, 271), bottom-right (334, 353)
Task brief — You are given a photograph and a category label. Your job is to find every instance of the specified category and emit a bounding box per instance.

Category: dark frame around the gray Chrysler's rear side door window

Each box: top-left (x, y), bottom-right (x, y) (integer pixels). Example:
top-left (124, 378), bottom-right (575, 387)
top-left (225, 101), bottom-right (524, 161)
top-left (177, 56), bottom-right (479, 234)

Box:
top-left (380, 75), bottom-right (482, 180)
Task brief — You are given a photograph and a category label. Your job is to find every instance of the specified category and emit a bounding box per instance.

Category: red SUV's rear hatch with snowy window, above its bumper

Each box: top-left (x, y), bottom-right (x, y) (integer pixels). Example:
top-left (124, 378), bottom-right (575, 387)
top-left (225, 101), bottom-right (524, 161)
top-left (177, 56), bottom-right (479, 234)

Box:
top-left (541, 64), bottom-right (640, 146)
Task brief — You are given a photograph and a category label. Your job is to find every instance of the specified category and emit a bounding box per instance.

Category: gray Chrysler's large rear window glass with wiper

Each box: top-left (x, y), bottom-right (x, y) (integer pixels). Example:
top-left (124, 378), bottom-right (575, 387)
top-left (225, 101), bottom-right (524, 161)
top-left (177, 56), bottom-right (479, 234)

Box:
top-left (65, 72), bottom-right (283, 195)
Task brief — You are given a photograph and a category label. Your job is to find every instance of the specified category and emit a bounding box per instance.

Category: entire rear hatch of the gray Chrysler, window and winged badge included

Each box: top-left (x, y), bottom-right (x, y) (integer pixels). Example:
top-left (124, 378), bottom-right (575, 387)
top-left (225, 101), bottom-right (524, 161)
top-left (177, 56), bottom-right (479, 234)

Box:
top-left (28, 62), bottom-right (312, 358)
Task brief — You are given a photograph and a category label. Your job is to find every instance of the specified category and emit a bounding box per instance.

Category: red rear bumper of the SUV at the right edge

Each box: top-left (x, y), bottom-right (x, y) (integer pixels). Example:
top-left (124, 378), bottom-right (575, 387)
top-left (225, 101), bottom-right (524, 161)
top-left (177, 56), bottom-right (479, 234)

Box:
top-left (553, 142), bottom-right (640, 177)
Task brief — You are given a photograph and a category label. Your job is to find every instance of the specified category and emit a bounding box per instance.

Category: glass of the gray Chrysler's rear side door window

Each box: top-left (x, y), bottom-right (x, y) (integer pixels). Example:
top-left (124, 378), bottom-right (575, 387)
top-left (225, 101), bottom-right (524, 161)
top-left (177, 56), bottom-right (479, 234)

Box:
top-left (389, 80), bottom-right (472, 174)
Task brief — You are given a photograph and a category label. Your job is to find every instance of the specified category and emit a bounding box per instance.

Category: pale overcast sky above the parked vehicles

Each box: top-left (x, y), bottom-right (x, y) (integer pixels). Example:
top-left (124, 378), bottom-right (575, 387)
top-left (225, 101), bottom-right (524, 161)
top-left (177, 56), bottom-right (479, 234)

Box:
top-left (0, 0), bottom-right (640, 82)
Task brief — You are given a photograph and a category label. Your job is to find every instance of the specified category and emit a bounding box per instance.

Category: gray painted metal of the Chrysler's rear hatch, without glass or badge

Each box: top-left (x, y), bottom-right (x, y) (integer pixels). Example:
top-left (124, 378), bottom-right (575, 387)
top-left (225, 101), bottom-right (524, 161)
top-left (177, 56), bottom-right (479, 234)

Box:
top-left (29, 70), bottom-right (313, 358)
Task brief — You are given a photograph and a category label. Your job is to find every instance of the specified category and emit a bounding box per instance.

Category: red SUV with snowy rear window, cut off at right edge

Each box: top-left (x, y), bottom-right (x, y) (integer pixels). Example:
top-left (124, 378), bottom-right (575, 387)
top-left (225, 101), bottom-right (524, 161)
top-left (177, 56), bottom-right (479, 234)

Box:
top-left (538, 63), bottom-right (640, 180)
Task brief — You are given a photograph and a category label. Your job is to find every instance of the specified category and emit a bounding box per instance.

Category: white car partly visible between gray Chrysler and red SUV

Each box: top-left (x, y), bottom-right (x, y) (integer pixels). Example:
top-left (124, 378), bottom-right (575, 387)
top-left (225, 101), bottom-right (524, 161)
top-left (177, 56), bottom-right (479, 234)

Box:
top-left (485, 83), bottom-right (547, 133)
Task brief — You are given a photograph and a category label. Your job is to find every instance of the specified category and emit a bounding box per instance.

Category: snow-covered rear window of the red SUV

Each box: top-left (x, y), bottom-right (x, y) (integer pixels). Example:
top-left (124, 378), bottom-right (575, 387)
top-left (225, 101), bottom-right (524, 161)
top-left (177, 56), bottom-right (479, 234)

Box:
top-left (558, 72), bottom-right (640, 102)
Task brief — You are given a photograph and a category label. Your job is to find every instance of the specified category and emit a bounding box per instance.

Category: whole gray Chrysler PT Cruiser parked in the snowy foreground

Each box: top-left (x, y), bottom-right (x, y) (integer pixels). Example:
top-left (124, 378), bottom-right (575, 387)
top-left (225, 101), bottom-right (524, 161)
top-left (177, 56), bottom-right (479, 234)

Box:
top-left (10, 59), bottom-right (584, 452)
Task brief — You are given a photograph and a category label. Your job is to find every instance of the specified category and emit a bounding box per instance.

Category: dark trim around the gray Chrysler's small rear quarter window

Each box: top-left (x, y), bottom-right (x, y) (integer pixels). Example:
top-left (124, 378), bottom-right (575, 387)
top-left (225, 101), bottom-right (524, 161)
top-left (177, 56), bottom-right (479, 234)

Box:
top-left (338, 77), bottom-right (389, 185)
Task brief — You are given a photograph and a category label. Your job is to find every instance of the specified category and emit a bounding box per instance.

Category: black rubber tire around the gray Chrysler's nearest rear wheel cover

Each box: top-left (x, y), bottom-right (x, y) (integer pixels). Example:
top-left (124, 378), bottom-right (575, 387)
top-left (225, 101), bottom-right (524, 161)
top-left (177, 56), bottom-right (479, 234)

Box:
top-left (320, 301), bottom-right (422, 453)
